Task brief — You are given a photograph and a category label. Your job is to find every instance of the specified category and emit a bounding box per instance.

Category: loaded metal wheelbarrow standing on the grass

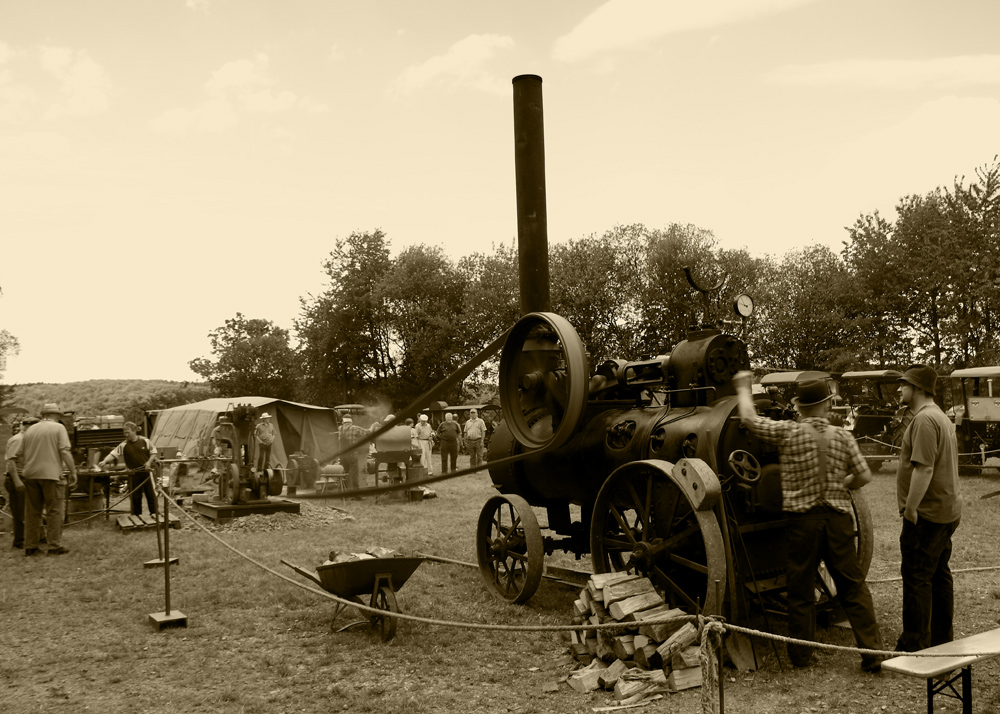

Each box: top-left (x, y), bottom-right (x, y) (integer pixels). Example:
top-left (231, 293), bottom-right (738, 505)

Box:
top-left (281, 557), bottom-right (426, 642)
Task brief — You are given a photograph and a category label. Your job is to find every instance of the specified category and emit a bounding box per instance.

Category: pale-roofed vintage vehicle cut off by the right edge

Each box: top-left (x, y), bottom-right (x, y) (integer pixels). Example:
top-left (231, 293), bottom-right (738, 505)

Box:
top-left (950, 367), bottom-right (1000, 471)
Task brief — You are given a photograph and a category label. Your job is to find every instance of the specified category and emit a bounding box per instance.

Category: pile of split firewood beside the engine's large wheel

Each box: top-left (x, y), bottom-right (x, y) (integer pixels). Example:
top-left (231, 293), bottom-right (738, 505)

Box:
top-left (567, 573), bottom-right (701, 704)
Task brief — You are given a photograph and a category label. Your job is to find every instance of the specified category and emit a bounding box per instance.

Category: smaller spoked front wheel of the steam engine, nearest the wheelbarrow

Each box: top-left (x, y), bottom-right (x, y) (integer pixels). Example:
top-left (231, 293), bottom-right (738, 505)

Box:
top-left (476, 494), bottom-right (545, 605)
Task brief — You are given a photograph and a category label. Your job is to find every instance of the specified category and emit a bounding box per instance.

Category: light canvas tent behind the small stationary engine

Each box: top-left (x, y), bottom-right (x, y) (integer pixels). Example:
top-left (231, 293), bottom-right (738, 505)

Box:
top-left (150, 397), bottom-right (340, 468)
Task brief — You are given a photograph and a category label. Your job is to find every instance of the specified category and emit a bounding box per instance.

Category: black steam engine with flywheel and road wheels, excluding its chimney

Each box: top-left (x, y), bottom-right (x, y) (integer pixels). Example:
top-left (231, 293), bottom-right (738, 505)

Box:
top-left (477, 301), bottom-right (872, 620)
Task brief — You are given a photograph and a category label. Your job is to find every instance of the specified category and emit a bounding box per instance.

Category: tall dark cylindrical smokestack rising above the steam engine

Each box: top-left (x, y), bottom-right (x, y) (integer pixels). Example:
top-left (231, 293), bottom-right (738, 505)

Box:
top-left (512, 74), bottom-right (549, 315)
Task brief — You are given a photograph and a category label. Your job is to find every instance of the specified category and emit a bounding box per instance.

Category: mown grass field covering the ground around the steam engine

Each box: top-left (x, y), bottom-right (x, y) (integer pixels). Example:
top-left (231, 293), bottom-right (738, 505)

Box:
top-left (0, 457), bottom-right (1000, 714)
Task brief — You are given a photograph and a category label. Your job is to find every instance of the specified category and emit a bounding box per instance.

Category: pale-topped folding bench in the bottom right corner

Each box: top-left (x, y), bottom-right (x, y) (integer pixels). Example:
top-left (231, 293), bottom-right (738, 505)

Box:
top-left (882, 628), bottom-right (1000, 714)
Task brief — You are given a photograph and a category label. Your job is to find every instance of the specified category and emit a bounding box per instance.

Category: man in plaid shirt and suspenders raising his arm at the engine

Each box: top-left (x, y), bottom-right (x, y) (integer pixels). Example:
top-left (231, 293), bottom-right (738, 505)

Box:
top-left (733, 372), bottom-right (882, 674)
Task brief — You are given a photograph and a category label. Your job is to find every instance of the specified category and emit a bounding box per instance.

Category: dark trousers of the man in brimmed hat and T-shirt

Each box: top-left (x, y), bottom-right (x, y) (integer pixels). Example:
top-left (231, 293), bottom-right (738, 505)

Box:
top-left (896, 516), bottom-right (958, 652)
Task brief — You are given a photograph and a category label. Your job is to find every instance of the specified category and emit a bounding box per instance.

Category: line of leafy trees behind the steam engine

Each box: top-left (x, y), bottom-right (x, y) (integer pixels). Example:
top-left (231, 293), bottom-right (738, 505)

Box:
top-left (178, 157), bottom-right (1000, 405)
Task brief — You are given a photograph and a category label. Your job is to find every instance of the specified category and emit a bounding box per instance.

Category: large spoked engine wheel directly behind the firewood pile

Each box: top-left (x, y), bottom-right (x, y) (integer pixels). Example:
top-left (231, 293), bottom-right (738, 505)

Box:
top-left (590, 460), bottom-right (726, 615)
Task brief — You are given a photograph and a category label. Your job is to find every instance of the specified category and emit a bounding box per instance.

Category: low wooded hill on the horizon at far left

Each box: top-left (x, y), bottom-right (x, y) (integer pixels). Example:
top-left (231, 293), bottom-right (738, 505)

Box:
top-left (5, 379), bottom-right (215, 421)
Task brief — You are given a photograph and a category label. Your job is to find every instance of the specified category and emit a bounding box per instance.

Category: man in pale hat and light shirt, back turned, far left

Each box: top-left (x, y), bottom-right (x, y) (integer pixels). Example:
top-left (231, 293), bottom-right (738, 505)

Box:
top-left (14, 403), bottom-right (76, 556)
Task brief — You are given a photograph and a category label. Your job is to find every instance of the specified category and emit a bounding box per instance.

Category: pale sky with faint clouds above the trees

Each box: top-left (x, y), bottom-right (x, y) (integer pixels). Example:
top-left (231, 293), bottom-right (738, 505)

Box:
top-left (0, 0), bottom-right (1000, 384)
